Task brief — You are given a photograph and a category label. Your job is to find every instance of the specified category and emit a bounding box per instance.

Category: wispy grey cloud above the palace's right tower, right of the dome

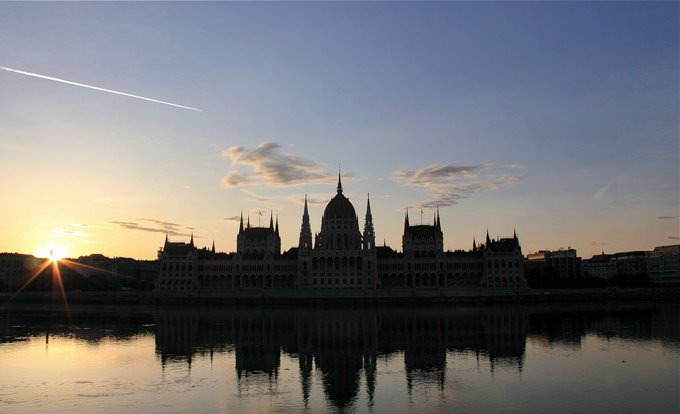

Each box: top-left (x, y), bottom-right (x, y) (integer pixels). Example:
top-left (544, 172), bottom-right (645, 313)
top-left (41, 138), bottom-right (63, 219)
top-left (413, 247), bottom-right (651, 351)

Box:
top-left (392, 164), bottom-right (524, 208)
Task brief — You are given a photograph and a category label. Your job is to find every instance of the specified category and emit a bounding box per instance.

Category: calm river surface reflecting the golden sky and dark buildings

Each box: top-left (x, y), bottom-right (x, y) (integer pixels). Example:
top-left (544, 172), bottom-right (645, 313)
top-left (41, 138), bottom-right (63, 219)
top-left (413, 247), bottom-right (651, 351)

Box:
top-left (0, 305), bottom-right (680, 414)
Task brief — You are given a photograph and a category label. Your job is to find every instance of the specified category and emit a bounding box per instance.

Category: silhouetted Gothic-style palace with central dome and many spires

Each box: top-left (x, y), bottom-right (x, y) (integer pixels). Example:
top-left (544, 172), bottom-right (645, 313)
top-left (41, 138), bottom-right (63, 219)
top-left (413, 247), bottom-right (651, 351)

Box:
top-left (156, 176), bottom-right (526, 295)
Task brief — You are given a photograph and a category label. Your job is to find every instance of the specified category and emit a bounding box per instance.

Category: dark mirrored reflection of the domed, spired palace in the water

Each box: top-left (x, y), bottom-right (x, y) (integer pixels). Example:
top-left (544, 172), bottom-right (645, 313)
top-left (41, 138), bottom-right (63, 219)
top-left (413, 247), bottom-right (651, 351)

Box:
top-left (154, 307), bottom-right (528, 409)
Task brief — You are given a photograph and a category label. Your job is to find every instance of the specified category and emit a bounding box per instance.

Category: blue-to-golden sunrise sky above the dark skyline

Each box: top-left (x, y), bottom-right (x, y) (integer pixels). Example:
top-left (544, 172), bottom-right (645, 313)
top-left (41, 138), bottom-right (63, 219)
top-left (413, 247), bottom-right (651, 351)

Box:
top-left (0, 2), bottom-right (680, 258)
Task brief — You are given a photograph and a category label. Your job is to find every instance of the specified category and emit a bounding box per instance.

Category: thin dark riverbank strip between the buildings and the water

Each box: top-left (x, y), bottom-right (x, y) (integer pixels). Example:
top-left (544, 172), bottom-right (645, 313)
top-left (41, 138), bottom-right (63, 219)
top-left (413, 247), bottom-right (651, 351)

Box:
top-left (0, 287), bottom-right (680, 306)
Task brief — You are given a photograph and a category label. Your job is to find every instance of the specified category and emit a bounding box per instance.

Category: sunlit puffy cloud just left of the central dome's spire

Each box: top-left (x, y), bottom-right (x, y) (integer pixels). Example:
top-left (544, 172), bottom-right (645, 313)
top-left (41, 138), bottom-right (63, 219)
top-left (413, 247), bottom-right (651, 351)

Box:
top-left (222, 142), bottom-right (335, 188)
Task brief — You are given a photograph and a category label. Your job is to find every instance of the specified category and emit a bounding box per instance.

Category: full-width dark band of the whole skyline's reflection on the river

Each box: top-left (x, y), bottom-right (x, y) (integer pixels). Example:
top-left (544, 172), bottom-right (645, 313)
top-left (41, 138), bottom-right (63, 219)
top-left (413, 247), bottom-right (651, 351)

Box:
top-left (0, 305), bottom-right (680, 411)
